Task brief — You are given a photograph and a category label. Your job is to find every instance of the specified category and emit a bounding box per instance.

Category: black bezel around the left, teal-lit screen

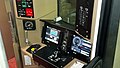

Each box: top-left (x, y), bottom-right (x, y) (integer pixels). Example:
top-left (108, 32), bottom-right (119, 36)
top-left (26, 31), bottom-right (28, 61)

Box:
top-left (42, 22), bottom-right (64, 46)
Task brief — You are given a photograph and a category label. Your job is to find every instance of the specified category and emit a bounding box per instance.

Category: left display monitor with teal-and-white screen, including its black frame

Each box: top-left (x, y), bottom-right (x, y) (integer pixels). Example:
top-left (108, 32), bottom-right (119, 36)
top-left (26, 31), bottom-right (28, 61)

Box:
top-left (42, 22), bottom-right (63, 45)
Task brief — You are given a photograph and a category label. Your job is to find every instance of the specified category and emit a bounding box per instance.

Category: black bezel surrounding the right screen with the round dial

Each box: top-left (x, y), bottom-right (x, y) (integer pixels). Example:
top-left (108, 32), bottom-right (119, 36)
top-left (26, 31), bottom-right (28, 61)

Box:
top-left (68, 32), bottom-right (92, 63)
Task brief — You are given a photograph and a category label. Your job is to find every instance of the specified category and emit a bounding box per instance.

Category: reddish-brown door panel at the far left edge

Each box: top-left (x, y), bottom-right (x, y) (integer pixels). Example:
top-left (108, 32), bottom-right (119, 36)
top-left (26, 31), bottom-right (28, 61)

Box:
top-left (0, 0), bottom-right (15, 60)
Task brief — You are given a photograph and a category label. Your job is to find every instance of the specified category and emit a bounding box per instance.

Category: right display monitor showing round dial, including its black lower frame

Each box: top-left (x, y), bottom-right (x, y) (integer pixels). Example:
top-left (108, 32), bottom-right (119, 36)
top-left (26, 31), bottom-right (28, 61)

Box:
top-left (70, 34), bottom-right (92, 62)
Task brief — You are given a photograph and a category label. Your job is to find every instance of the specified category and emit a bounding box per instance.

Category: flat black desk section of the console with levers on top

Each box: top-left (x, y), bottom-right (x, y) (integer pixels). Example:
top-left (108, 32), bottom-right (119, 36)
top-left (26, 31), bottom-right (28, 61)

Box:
top-left (33, 46), bottom-right (73, 68)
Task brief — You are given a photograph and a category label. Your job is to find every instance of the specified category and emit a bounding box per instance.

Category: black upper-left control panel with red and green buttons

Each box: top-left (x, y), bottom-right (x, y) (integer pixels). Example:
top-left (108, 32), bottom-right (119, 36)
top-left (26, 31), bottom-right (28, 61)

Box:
top-left (16, 0), bottom-right (34, 18)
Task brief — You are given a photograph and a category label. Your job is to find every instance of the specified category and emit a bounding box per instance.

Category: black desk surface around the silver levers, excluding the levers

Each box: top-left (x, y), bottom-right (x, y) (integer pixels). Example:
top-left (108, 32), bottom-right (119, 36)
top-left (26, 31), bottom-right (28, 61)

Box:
top-left (34, 46), bottom-right (73, 68)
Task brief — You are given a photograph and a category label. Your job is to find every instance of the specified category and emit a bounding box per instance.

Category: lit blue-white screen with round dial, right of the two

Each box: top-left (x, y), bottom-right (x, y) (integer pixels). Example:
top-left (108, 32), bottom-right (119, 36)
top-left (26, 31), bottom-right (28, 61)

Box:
top-left (71, 35), bottom-right (91, 57)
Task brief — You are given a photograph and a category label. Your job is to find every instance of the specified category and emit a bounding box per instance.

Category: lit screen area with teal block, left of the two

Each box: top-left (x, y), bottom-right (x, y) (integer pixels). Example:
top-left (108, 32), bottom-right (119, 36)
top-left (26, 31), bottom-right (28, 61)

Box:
top-left (45, 26), bottom-right (60, 44)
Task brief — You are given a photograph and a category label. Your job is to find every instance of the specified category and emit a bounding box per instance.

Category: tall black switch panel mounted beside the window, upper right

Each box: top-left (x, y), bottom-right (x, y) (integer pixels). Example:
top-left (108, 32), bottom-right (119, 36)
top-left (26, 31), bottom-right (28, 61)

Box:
top-left (76, 0), bottom-right (94, 39)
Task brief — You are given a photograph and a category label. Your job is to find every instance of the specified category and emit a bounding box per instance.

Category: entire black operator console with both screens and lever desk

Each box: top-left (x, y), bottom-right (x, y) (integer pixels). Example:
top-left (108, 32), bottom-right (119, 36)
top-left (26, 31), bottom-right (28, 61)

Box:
top-left (33, 20), bottom-right (92, 68)
